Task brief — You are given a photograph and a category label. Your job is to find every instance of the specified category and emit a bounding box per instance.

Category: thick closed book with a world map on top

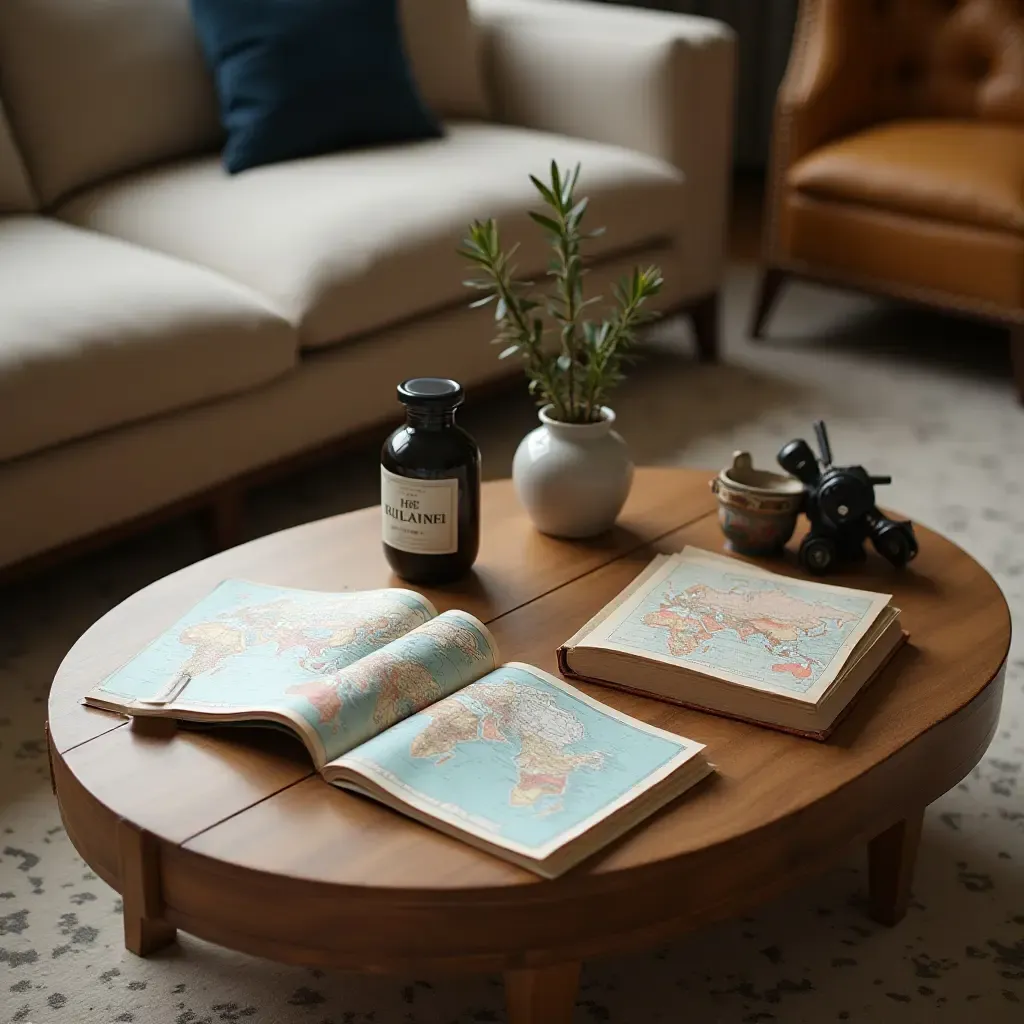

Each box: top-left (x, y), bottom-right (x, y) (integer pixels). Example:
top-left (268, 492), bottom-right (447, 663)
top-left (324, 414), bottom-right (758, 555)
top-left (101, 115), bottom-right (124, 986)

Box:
top-left (558, 548), bottom-right (906, 739)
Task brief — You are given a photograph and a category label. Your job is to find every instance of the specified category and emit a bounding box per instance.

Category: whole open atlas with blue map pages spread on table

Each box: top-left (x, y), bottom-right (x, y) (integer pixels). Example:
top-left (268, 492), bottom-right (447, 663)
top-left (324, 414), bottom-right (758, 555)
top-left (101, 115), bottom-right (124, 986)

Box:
top-left (85, 580), bottom-right (712, 878)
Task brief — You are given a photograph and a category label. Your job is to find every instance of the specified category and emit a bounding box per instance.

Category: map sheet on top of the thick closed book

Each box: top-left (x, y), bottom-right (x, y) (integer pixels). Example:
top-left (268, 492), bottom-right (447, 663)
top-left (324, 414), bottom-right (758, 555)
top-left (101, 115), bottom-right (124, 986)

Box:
top-left (577, 548), bottom-right (890, 702)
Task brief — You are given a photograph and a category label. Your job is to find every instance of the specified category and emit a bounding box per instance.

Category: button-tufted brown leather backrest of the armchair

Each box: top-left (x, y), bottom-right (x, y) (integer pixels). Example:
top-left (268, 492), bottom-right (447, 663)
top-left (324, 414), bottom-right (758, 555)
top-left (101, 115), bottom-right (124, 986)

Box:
top-left (868, 0), bottom-right (1024, 122)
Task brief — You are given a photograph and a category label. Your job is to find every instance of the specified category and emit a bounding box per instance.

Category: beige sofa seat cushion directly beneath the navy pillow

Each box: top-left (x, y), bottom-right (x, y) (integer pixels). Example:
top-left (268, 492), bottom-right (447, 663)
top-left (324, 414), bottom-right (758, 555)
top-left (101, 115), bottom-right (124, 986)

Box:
top-left (59, 123), bottom-right (684, 347)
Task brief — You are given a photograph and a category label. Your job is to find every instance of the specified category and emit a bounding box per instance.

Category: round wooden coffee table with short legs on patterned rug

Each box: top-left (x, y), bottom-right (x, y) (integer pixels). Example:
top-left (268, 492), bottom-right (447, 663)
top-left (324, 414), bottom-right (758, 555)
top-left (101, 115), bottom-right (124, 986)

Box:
top-left (48, 469), bottom-right (1010, 1024)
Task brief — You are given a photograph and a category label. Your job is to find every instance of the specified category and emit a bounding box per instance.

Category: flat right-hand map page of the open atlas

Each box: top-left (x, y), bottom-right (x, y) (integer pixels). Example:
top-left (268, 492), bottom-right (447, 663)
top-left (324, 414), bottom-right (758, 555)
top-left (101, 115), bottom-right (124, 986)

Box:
top-left (328, 663), bottom-right (702, 860)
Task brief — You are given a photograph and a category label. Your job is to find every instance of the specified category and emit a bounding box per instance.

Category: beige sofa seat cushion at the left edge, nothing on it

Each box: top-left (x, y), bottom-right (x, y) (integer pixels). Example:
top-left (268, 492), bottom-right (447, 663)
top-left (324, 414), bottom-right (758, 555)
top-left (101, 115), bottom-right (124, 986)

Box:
top-left (0, 217), bottom-right (296, 460)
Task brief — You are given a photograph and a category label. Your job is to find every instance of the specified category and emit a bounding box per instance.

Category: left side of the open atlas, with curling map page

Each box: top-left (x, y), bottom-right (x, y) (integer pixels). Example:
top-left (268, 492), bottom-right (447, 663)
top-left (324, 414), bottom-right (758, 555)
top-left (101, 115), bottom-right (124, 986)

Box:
top-left (86, 580), bottom-right (497, 767)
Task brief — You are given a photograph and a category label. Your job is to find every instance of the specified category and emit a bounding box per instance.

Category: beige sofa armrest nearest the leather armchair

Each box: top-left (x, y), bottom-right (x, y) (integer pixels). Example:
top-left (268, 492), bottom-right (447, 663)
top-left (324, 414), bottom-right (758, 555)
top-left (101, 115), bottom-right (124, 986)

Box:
top-left (471, 0), bottom-right (735, 297)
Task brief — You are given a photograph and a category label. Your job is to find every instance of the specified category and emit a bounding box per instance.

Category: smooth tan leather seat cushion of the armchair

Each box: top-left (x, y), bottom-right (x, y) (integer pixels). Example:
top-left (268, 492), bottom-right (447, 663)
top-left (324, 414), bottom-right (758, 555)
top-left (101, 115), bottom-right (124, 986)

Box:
top-left (787, 121), bottom-right (1024, 233)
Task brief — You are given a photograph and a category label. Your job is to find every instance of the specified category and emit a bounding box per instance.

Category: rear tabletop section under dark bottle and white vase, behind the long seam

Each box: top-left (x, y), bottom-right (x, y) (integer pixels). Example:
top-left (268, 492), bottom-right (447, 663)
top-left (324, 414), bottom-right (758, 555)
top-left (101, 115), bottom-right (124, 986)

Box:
top-left (49, 469), bottom-right (714, 752)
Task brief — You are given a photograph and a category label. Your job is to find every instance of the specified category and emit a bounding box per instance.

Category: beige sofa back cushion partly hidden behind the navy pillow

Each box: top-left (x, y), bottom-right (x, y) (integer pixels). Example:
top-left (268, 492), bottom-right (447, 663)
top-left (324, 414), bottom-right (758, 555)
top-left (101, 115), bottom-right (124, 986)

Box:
top-left (0, 0), bottom-right (486, 205)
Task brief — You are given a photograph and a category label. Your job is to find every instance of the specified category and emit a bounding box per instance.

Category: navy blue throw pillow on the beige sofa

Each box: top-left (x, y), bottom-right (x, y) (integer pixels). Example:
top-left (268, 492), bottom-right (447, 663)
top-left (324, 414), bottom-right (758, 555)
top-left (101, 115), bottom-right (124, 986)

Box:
top-left (191, 0), bottom-right (441, 174)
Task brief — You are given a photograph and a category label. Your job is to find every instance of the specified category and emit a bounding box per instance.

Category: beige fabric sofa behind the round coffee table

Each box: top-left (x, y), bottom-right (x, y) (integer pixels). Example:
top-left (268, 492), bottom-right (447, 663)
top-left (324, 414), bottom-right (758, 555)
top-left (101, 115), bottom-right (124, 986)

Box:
top-left (0, 0), bottom-right (734, 572)
